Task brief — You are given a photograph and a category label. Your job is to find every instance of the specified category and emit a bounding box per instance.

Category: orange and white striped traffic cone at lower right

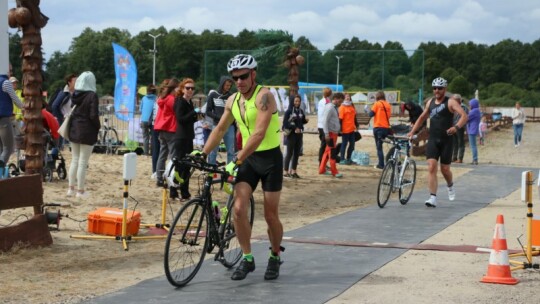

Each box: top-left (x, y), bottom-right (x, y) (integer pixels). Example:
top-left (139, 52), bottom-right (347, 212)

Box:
top-left (480, 214), bottom-right (519, 285)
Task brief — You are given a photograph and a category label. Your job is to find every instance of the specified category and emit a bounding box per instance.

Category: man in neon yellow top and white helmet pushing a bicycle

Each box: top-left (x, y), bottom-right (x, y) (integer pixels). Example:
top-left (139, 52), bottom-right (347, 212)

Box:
top-left (202, 54), bottom-right (283, 280)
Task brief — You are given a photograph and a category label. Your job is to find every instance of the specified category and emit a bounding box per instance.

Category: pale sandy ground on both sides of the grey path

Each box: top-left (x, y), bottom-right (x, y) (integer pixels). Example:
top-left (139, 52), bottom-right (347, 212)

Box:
top-left (0, 117), bottom-right (540, 303)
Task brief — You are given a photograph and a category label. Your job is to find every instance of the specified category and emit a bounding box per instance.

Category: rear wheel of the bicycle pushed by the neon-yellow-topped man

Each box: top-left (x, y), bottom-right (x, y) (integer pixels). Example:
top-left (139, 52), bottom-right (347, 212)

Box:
top-left (218, 195), bottom-right (255, 268)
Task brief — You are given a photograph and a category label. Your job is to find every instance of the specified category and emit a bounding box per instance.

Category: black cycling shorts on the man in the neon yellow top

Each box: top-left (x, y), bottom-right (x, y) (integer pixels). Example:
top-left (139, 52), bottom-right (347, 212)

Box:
top-left (236, 146), bottom-right (283, 192)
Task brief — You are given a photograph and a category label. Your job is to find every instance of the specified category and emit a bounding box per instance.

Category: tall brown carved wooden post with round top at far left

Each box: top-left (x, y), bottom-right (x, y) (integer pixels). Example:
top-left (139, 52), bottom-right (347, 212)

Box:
top-left (8, 0), bottom-right (49, 174)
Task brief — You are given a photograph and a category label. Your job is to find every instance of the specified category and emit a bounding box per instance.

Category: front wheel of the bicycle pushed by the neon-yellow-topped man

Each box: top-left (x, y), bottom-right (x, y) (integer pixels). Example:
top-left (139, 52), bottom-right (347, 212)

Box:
top-left (164, 198), bottom-right (209, 287)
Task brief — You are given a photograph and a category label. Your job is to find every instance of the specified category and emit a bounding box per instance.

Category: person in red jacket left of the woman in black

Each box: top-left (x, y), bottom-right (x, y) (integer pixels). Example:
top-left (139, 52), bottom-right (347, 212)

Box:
top-left (154, 78), bottom-right (179, 187)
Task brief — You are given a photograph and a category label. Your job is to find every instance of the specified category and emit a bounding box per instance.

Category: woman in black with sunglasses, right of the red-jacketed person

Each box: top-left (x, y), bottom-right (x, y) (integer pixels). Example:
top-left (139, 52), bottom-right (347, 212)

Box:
top-left (174, 78), bottom-right (200, 200)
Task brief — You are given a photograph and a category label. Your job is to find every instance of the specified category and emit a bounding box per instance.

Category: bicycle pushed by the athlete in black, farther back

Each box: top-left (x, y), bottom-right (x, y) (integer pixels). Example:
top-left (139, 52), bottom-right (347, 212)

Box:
top-left (377, 135), bottom-right (416, 208)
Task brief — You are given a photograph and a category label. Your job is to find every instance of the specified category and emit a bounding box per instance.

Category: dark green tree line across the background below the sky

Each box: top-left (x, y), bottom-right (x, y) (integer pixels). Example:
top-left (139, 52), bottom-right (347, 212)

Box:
top-left (9, 26), bottom-right (540, 107)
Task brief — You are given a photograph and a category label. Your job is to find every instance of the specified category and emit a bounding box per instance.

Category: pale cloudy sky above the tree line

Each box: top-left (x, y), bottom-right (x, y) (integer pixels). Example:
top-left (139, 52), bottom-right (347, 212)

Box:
top-left (8, 0), bottom-right (540, 58)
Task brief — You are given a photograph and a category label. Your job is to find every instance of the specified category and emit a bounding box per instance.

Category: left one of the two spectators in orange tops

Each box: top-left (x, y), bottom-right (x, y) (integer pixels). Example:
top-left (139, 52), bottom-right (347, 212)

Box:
top-left (339, 94), bottom-right (358, 165)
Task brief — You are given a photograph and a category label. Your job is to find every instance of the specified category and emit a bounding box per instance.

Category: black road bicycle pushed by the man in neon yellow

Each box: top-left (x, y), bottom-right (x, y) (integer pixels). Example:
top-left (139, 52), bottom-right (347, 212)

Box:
top-left (164, 155), bottom-right (255, 287)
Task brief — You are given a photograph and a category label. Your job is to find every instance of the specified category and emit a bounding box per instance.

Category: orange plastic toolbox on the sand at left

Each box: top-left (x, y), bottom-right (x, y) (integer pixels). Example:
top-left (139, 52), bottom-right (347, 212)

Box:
top-left (88, 208), bottom-right (141, 236)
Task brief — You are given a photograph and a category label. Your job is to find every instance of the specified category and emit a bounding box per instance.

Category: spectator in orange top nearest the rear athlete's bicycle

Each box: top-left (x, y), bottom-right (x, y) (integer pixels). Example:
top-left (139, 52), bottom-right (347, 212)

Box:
top-left (369, 91), bottom-right (392, 169)
